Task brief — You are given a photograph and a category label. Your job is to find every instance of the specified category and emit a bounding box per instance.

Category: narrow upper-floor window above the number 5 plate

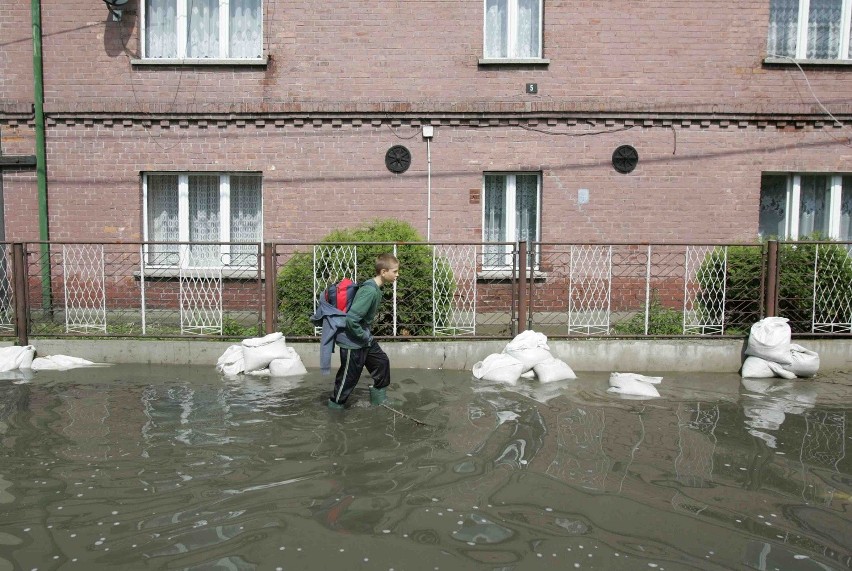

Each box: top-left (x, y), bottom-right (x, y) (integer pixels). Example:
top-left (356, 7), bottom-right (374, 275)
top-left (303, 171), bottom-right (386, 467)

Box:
top-left (484, 0), bottom-right (543, 59)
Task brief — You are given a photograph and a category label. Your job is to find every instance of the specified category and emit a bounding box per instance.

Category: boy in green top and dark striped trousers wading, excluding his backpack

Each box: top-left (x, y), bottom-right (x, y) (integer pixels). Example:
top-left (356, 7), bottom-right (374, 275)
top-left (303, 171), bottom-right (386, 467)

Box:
top-left (328, 254), bottom-right (399, 409)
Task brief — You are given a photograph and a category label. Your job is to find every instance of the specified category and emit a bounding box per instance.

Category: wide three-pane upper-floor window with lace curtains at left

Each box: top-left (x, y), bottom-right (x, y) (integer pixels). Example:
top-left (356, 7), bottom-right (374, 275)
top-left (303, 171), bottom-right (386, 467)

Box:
top-left (142, 0), bottom-right (263, 59)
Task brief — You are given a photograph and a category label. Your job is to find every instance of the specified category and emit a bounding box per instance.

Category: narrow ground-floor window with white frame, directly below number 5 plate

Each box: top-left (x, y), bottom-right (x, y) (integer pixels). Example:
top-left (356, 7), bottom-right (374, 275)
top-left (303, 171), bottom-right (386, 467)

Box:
top-left (482, 173), bottom-right (541, 268)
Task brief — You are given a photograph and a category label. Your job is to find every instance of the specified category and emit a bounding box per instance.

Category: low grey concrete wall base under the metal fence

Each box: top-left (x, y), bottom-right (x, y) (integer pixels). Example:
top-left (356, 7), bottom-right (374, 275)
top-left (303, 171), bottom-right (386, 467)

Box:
top-left (13, 338), bottom-right (852, 373)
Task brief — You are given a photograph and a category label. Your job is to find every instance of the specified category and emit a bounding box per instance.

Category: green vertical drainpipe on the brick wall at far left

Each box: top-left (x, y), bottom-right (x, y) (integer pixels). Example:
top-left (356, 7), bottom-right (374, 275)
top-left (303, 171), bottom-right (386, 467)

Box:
top-left (30, 0), bottom-right (53, 313)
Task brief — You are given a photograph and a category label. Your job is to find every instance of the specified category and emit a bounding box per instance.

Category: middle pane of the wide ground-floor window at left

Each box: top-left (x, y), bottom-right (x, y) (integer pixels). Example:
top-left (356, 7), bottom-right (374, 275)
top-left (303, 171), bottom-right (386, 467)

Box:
top-left (189, 175), bottom-right (222, 266)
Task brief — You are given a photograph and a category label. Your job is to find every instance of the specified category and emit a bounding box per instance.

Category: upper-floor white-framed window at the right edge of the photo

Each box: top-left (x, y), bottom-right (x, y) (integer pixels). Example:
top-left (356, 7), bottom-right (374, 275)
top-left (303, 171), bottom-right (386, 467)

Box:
top-left (766, 0), bottom-right (852, 60)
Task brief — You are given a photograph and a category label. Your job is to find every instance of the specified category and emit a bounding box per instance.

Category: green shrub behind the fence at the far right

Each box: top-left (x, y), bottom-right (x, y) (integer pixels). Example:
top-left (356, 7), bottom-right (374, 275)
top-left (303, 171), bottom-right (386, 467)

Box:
top-left (699, 236), bottom-right (852, 333)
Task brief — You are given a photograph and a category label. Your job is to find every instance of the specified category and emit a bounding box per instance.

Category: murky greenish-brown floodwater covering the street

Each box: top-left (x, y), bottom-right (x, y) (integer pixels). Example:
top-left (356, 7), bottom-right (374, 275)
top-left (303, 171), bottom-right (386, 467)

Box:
top-left (0, 365), bottom-right (852, 571)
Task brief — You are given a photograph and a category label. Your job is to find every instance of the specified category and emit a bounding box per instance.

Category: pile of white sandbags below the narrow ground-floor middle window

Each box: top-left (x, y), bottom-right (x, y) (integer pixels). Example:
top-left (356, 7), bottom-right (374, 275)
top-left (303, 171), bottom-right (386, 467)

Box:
top-left (473, 330), bottom-right (577, 384)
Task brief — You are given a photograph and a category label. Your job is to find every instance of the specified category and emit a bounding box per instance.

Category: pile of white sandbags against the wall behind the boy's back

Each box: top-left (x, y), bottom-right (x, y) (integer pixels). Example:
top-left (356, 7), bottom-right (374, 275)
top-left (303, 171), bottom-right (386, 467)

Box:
top-left (216, 332), bottom-right (308, 377)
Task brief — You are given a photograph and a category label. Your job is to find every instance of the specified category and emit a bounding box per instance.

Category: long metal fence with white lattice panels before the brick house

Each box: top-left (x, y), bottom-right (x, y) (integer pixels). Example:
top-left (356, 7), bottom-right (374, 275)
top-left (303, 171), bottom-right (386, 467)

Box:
top-left (6, 241), bottom-right (852, 343)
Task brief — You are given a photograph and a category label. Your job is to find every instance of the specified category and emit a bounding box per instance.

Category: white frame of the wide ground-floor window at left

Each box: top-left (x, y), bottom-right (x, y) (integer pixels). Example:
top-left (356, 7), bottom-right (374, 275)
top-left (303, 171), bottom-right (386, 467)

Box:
top-left (142, 171), bottom-right (263, 269)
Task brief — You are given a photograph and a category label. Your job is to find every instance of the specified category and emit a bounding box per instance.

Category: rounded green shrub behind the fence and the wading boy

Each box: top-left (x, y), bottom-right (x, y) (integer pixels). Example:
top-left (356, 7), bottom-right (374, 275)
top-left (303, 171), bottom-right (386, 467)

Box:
top-left (277, 220), bottom-right (455, 335)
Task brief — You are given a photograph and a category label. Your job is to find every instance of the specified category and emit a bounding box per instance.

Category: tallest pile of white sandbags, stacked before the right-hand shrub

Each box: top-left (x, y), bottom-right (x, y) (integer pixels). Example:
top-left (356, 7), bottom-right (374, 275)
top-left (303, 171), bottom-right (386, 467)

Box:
top-left (741, 317), bottom-right (819, 379)
